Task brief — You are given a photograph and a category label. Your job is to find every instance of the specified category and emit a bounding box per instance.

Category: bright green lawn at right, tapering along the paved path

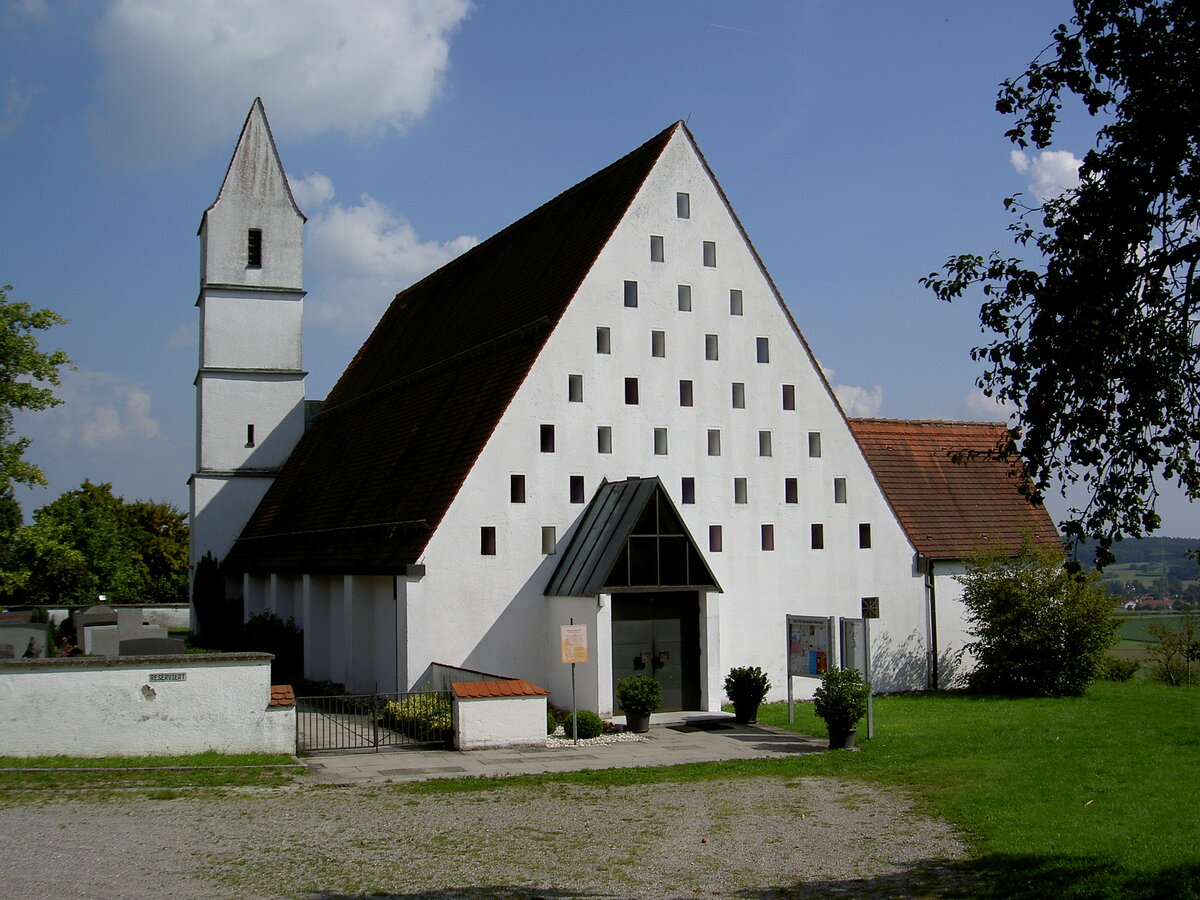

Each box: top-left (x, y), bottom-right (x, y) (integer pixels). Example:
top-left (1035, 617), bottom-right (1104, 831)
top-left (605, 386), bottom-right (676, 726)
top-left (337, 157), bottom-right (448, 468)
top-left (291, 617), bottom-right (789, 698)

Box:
top-left (396, 682), bottom-right (1200, 900)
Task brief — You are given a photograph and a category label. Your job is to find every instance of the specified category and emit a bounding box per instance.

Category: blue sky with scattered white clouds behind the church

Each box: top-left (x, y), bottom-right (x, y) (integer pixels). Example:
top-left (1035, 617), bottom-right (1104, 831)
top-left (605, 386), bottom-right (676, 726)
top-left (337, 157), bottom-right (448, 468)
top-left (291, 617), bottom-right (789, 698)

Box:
top-left (0, 0), bottom-right (1200, 536)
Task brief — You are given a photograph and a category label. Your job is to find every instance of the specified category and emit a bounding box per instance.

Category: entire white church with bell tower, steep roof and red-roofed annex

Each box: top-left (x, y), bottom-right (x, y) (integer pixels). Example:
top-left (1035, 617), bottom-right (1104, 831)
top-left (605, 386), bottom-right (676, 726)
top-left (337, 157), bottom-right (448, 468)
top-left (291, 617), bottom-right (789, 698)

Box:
top-left (191, 101), bottom-right (1057, 714)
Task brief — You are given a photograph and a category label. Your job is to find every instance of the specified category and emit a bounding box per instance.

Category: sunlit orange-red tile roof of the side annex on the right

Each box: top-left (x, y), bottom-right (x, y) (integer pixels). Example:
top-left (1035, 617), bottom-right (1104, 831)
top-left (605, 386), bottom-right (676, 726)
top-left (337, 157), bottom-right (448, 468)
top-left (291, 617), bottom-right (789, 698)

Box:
top-left (850, 419), bottom-right (1062, 559)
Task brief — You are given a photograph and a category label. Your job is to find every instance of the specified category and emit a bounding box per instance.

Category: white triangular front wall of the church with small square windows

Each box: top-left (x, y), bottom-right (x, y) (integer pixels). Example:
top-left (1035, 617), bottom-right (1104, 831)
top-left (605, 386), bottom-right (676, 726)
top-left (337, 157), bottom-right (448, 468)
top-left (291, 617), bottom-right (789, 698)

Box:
top-left (388, 127), bottom-right (928, 714)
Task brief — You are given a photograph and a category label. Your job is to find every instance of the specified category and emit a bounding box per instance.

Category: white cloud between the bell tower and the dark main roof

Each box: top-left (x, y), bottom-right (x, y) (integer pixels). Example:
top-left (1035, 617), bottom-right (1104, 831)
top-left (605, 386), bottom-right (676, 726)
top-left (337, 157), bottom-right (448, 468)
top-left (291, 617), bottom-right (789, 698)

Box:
top-left (302, 184), bottom-right (479, 330)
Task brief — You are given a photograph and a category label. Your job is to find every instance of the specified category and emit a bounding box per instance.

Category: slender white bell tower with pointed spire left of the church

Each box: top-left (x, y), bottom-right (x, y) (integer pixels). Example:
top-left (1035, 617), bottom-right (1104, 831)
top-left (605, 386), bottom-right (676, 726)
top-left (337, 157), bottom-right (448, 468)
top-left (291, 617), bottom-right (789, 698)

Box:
top-left (190, 98), bottom-right (306, 574)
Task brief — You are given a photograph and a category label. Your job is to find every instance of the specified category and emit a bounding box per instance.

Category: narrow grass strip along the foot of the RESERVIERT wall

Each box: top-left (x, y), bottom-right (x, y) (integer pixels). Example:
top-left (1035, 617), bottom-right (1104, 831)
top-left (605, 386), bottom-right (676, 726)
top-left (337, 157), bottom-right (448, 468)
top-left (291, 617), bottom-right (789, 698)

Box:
top-left (0, 752), bottom-right (300, 799)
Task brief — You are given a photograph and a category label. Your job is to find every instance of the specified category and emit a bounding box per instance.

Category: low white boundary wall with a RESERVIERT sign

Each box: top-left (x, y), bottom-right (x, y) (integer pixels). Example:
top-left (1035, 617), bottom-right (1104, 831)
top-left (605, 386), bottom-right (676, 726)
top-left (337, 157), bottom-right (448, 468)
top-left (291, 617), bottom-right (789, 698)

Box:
top-left (0, 654), bottom-right (295, 756)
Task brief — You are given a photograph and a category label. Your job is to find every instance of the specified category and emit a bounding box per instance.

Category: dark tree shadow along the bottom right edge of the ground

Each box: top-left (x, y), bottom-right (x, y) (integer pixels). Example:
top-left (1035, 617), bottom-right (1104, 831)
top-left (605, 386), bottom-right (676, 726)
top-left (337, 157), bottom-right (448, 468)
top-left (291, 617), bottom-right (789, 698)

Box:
top-left (307, 854), bottom-right (1200, 900)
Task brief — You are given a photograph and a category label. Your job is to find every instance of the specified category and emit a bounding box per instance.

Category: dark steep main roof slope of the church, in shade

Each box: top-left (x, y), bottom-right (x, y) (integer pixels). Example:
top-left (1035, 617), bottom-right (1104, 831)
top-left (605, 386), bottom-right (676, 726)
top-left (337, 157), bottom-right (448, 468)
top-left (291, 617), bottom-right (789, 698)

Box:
top-left (226, 122), bottom-right (683, 574)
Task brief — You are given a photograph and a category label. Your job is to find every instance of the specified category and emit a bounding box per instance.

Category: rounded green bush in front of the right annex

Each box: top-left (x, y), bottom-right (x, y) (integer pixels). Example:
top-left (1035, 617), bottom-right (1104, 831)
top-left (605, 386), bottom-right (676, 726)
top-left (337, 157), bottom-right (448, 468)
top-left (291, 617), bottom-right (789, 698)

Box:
top-left (958, 553), bottom-right (1117, 697)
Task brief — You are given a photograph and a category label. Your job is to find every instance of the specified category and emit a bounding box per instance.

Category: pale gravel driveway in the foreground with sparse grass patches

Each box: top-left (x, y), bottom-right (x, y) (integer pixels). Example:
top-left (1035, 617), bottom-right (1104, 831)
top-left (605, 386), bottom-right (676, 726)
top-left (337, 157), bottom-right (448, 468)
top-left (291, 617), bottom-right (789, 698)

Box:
top-left (0, 778), bottom-right (965, 900)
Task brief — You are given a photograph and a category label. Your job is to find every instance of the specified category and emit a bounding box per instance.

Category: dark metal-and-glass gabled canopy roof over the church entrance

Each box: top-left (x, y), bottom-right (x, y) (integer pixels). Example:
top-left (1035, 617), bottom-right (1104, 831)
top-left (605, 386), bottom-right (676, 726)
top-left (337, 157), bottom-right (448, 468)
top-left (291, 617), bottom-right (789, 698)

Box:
top-left (545, 476), bottom-right (721, 596)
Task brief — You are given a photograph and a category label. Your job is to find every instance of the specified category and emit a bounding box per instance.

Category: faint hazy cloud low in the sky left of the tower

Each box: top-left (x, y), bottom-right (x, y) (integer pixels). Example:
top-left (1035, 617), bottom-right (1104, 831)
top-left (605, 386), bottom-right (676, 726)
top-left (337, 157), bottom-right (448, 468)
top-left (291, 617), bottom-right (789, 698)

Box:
top-left (36, 370), bottom-right (163, 450)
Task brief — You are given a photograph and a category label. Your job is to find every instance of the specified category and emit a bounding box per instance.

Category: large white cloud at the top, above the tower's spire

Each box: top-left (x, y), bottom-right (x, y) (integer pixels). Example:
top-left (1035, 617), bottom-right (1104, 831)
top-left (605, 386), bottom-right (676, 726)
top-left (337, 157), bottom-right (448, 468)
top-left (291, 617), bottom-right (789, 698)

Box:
top-left (91, 0), bottom-right (470, 164)
